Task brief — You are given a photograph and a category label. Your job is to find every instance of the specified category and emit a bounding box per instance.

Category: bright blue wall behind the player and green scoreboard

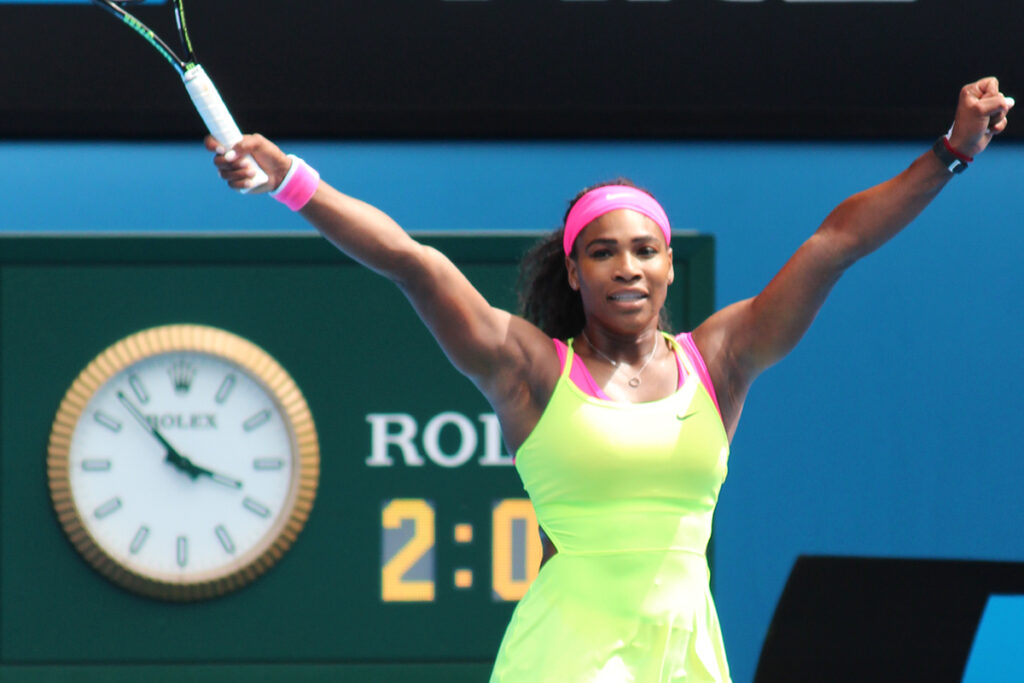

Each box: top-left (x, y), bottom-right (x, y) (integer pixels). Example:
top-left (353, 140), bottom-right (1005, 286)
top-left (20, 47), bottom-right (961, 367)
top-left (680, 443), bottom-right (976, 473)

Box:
top-left (0, 140), bottom-right (1024, 682)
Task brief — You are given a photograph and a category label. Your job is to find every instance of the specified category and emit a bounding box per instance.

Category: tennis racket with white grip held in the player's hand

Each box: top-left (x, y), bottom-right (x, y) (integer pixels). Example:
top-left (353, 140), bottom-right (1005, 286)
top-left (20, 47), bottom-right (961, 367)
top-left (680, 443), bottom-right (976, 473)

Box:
top-left (92, 0), bottom-right (267, 193)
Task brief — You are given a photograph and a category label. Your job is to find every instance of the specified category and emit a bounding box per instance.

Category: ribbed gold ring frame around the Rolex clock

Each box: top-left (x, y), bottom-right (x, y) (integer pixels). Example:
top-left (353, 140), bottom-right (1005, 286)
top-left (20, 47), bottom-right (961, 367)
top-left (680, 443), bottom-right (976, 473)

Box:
top-left (46, 325), bottom-right (319, 601)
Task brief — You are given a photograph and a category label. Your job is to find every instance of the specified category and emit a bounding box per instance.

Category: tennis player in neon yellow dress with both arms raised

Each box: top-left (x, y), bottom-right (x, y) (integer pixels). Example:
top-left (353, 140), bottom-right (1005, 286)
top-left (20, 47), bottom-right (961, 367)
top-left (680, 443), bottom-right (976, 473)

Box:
top-left (207, 78), bottom-right (1013, 683)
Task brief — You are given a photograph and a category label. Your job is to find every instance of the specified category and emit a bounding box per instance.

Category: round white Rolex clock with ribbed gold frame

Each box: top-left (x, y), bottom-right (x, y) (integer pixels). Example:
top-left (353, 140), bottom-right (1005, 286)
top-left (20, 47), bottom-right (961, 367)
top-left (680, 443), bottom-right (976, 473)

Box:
top-left (47, 325), bottom-right (319, 600)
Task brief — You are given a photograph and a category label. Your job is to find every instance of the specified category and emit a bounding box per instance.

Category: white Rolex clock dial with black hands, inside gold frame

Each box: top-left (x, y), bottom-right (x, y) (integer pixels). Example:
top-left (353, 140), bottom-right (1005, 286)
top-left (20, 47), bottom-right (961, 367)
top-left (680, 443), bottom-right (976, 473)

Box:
top-left (69, 352), bottom-right (296, 582)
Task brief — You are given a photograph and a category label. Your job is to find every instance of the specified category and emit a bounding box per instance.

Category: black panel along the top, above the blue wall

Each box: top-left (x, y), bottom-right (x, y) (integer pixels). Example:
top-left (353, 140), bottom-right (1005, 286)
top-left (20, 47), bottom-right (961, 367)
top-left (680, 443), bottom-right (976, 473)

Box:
top-left (0, 0), bottom-right (1024, 138)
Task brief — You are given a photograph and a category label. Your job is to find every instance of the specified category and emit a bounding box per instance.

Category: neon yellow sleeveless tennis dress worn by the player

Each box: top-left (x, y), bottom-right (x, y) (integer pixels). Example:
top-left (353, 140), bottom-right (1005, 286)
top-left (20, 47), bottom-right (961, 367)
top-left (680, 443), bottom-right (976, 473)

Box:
top-left (490, 335), bottom-right (730, 683)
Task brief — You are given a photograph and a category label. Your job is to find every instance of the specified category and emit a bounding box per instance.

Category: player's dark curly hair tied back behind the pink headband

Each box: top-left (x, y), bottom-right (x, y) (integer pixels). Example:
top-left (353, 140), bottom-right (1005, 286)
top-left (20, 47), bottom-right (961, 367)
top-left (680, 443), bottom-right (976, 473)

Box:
top-left (517, 177), bottom-right (672, 339)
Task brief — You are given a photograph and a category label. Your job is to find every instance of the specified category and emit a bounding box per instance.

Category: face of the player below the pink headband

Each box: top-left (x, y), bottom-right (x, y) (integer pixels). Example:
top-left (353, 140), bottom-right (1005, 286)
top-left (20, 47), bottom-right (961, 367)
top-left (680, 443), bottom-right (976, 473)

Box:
top-left (565, 209), bottom-right (675, 333)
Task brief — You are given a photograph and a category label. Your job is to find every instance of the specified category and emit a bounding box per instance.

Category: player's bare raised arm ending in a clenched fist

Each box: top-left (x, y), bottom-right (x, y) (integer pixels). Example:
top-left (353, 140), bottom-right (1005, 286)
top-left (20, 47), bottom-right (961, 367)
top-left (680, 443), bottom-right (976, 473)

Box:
top-left (694, 78), bottom-right (1013, 437)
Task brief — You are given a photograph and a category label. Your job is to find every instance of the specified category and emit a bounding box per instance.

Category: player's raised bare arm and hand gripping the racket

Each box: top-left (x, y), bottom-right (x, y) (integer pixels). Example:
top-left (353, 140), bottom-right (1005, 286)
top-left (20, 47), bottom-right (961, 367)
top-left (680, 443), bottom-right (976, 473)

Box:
top-left (207, 135), bottom-right (557, 429)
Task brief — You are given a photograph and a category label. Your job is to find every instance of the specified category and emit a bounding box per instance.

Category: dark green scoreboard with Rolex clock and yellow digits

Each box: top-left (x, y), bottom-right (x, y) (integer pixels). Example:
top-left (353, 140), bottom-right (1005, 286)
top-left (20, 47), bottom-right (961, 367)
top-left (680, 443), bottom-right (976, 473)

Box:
top-left (0, 233), bottom-right (714, 682)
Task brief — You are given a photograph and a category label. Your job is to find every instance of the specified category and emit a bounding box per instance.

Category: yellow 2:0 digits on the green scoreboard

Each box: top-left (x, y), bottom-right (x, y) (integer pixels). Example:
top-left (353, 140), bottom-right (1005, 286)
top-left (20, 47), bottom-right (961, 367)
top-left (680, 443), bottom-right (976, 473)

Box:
top-left (381, 498), bottom-right (542, 602)
